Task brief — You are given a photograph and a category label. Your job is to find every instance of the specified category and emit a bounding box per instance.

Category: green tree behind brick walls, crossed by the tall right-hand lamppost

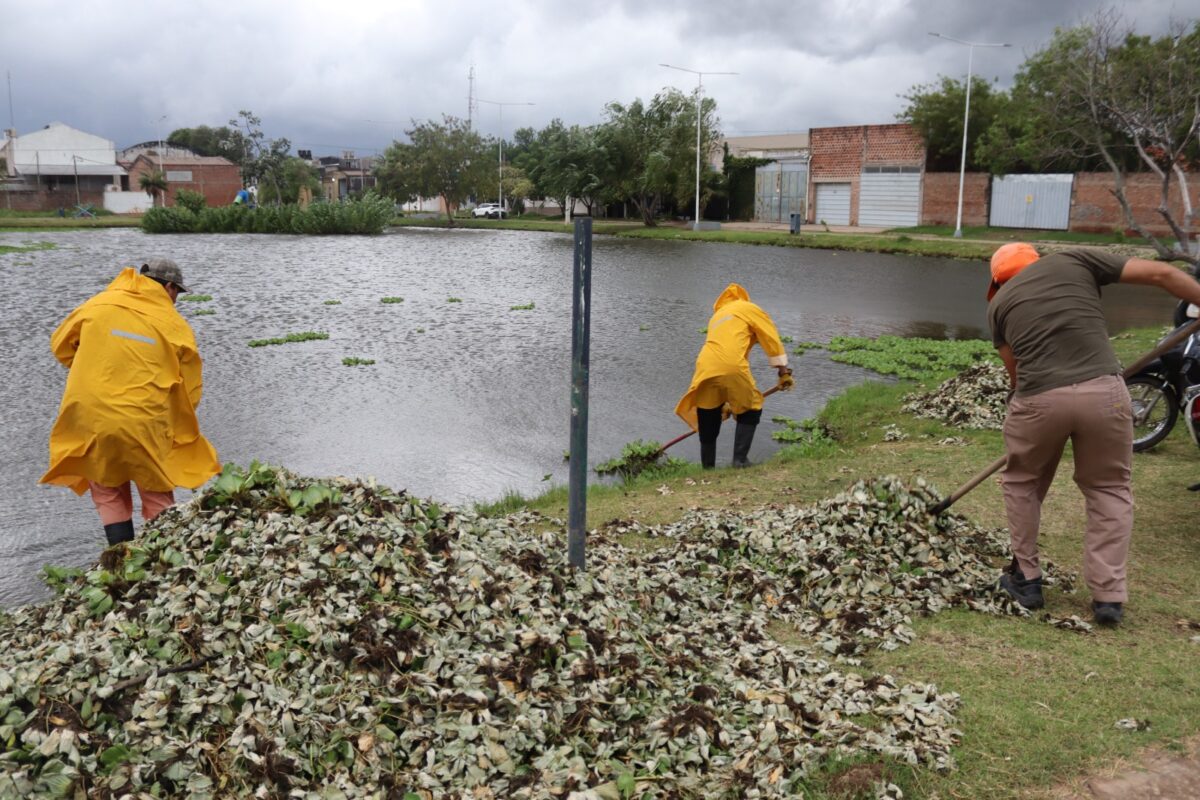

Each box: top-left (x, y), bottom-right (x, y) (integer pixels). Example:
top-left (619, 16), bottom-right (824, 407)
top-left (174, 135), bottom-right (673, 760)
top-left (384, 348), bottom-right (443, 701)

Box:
top-left (896, 76), bottom-right (1008, 172)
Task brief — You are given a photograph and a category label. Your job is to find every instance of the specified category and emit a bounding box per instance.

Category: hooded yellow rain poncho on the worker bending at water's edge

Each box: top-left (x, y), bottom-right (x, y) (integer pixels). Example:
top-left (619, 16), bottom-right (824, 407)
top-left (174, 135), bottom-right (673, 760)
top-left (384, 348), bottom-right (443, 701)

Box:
top-left (676, 283), bottom-right (787, 431)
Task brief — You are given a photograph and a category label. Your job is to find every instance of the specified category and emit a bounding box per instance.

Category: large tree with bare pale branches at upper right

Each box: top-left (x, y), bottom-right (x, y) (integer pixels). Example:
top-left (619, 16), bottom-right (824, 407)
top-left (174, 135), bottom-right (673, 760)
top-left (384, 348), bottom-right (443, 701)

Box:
top-left (993, 11), bottom-right (1200, 263)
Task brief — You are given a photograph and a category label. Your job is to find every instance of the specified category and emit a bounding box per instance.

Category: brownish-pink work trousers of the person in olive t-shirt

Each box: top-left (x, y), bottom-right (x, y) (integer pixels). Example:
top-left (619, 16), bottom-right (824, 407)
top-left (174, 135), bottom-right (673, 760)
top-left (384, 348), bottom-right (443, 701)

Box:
top-left (1002, 375), bottom-right (1133, 602)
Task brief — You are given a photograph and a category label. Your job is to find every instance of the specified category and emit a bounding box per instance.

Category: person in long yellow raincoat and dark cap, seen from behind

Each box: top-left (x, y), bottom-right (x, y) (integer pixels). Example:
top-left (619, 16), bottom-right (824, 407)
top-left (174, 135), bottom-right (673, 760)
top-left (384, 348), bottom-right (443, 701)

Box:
top-left (41, 259), bottom-right (220, 545)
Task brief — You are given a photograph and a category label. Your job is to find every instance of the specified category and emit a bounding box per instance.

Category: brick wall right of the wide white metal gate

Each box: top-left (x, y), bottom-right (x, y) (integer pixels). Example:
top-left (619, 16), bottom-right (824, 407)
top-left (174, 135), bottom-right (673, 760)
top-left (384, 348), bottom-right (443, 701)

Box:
top-left (1069, 173), bottom-right (1200, 239)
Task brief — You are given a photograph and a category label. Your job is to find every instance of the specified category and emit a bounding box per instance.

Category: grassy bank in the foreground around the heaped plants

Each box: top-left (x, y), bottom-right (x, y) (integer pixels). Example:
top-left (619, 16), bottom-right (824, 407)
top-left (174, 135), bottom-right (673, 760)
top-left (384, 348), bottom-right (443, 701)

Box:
top-left (484, 329), bottom-right (1200, 799)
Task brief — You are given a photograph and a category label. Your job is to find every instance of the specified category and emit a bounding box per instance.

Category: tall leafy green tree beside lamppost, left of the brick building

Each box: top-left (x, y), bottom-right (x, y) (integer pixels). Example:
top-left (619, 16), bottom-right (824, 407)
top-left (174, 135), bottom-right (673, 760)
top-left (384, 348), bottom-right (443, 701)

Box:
top-left (596, 89), bottom-right (720, 227)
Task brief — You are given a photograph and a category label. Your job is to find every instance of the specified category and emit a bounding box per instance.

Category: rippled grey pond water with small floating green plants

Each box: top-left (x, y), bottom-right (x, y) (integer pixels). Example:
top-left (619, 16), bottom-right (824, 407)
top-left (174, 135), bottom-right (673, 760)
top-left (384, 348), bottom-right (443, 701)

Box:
top-left (0, 228), bottom-right (1172, 606)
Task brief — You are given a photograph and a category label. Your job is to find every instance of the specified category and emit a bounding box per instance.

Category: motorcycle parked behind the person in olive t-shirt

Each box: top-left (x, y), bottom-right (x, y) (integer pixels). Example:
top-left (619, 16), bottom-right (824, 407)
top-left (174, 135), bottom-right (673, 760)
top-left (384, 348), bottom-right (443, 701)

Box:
top-left (1126, 302), bottom-right (1200, 452)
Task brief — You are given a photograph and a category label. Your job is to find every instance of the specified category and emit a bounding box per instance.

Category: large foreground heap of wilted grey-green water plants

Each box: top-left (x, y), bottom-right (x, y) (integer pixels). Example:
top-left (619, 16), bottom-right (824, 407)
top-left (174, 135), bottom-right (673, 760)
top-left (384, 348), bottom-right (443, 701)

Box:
top-left (0, 464), bottom-right (1060, 800)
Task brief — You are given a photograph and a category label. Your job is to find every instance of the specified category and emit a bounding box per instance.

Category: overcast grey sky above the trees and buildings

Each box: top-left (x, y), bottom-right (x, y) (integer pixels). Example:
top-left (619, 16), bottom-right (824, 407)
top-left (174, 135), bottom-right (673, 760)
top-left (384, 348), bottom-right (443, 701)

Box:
top-left (0, 0), bottom-right (1200, 155)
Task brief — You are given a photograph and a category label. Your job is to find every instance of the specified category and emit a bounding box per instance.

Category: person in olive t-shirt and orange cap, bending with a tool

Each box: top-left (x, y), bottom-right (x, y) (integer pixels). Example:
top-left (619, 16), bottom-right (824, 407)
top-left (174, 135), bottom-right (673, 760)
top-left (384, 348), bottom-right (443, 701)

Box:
top-left (988, 242), bottom-right (1200, 625)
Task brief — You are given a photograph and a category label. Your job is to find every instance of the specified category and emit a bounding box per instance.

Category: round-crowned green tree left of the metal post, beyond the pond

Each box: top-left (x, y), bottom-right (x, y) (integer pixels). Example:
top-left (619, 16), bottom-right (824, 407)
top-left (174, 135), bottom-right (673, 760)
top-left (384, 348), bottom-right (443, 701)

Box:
top-left (374, 115), bottom-right (497, 224)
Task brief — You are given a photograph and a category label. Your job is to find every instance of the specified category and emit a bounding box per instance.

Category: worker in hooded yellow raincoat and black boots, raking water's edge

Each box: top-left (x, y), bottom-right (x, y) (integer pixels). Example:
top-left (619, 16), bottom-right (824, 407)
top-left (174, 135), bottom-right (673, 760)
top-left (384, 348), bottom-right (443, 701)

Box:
top-left (676, 283), bottom-right (793, 469)
